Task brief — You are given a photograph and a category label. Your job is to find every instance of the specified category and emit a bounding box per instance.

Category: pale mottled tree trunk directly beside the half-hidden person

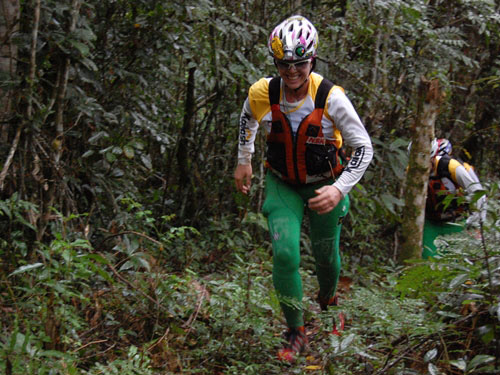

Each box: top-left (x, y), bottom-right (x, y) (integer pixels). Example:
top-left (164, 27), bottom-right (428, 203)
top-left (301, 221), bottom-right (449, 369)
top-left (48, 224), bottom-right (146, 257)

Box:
top-left (399, 78), bottom-right (442, 263)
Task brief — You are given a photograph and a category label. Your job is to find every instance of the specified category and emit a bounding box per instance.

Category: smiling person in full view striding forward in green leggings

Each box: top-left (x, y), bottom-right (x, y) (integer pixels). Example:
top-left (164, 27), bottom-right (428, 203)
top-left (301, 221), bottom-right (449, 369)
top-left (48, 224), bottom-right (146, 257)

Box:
top-left (234, 15), bottom-right (373, 361)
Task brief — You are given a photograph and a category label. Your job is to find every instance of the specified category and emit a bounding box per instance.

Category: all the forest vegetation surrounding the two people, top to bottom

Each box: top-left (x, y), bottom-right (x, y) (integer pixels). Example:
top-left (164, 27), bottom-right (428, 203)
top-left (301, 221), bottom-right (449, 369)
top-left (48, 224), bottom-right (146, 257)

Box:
top-left (0, 0), bottom-right (500, 375)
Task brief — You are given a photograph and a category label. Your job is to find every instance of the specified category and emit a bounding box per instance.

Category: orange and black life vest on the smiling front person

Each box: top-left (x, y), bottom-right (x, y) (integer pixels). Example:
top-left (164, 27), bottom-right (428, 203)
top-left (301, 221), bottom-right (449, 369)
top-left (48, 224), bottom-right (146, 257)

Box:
top-left (266, 77), bottom-right (343, 184)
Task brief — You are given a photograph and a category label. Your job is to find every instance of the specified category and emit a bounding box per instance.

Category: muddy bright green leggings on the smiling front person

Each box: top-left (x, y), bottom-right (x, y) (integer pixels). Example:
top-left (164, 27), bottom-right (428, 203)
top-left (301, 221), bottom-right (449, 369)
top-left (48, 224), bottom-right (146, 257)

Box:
top-left (263, 172), bottom-right (349, 328)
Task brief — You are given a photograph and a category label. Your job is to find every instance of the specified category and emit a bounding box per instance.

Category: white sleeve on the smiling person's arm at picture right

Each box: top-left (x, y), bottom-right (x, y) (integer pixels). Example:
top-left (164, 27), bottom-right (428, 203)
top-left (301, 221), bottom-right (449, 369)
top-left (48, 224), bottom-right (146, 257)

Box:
top-left (327, 88), bottom-right (373, 196)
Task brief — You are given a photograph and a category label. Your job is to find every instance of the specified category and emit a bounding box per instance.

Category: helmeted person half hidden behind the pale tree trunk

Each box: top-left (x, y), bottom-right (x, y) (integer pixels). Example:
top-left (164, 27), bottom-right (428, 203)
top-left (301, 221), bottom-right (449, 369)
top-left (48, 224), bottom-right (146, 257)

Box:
top-left (422, 138), bottom-right (487, 259)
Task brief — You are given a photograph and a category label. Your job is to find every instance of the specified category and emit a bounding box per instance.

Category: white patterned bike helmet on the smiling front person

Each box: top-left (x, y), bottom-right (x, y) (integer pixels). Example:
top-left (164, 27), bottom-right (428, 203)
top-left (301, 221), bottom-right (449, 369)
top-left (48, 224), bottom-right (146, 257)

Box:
top-left (267, 15), bottom-right (319, 61)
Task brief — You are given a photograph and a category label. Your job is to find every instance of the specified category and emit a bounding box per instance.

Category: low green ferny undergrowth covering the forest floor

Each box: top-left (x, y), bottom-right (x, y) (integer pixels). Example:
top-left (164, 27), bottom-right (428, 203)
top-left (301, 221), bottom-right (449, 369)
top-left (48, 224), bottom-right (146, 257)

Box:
top-left (0, 183), bottom-right (500, 375)
